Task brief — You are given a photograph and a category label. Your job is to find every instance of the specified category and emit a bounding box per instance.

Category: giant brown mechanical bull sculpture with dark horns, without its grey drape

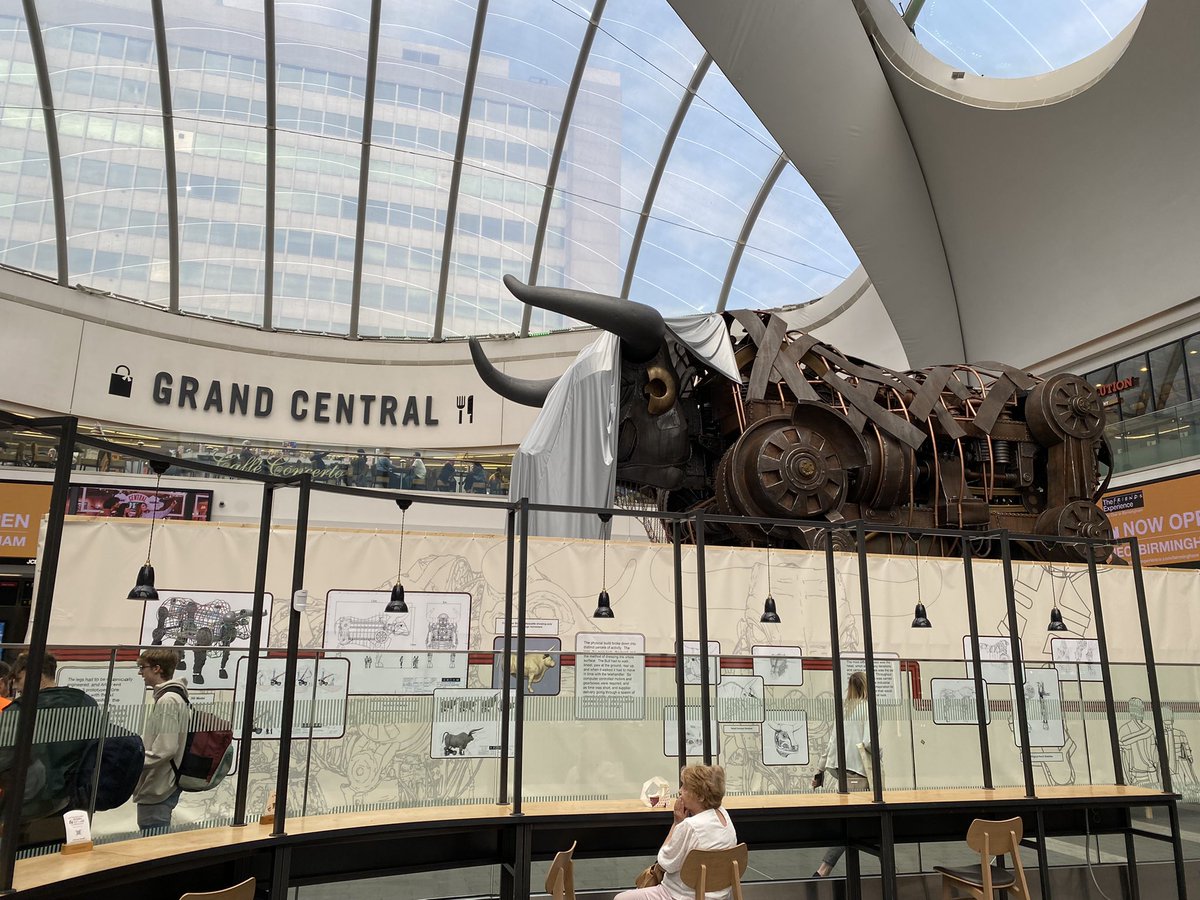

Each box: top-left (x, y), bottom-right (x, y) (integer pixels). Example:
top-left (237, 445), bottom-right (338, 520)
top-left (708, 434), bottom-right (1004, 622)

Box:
top-left (472, 276), bottom-right (1111, 559)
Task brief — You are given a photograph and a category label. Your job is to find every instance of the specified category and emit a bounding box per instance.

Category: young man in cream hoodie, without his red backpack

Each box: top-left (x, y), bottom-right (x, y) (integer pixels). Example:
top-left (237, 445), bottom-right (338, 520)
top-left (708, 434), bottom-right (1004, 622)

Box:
top-left (133, 647), bottom-right (190, 834)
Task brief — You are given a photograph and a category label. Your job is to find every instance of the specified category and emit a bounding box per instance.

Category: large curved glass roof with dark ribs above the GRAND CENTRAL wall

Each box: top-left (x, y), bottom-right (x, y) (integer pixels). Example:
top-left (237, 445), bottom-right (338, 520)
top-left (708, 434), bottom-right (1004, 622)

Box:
top-left (0, 0), bottom-right (864, 340)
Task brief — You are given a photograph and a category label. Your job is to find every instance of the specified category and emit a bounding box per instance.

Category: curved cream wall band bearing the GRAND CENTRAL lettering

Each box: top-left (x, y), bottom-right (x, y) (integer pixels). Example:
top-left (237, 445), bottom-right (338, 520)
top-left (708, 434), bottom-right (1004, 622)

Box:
top-left (0, 294), bottom-right (547, 448)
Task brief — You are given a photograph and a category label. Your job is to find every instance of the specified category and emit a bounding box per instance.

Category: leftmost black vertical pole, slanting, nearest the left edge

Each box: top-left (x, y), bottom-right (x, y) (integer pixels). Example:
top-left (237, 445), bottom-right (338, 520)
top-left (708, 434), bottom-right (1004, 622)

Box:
top-left (0, 416), bottom-right (79, 892)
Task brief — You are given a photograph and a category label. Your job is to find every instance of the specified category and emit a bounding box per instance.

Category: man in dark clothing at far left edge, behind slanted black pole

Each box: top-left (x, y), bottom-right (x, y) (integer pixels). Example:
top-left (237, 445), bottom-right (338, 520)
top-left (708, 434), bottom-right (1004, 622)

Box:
top-left (0, 652), bottom-right (100, 847)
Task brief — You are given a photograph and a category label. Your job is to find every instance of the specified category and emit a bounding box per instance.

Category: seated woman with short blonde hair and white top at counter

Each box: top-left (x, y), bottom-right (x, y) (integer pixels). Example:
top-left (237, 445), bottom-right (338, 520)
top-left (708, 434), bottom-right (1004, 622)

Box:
top-left (616, 766), bottom-right (738, 900)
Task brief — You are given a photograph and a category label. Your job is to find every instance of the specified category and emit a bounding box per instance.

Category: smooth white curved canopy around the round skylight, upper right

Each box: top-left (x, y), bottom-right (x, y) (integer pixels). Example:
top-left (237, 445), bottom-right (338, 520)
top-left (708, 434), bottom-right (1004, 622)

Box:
top-left (673, 0), bottom-right (1200, 365)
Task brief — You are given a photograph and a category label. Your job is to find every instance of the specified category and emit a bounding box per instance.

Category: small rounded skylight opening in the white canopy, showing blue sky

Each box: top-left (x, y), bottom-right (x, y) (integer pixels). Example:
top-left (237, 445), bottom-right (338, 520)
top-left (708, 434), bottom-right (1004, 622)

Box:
top-left (898, 0), bottom-right (1146, 78)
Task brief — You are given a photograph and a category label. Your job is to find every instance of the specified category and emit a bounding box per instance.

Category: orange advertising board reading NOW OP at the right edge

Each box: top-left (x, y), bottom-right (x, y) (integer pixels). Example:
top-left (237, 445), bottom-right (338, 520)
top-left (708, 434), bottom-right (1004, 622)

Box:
top-left (1100, 475), bottom-right (1200, 565)
